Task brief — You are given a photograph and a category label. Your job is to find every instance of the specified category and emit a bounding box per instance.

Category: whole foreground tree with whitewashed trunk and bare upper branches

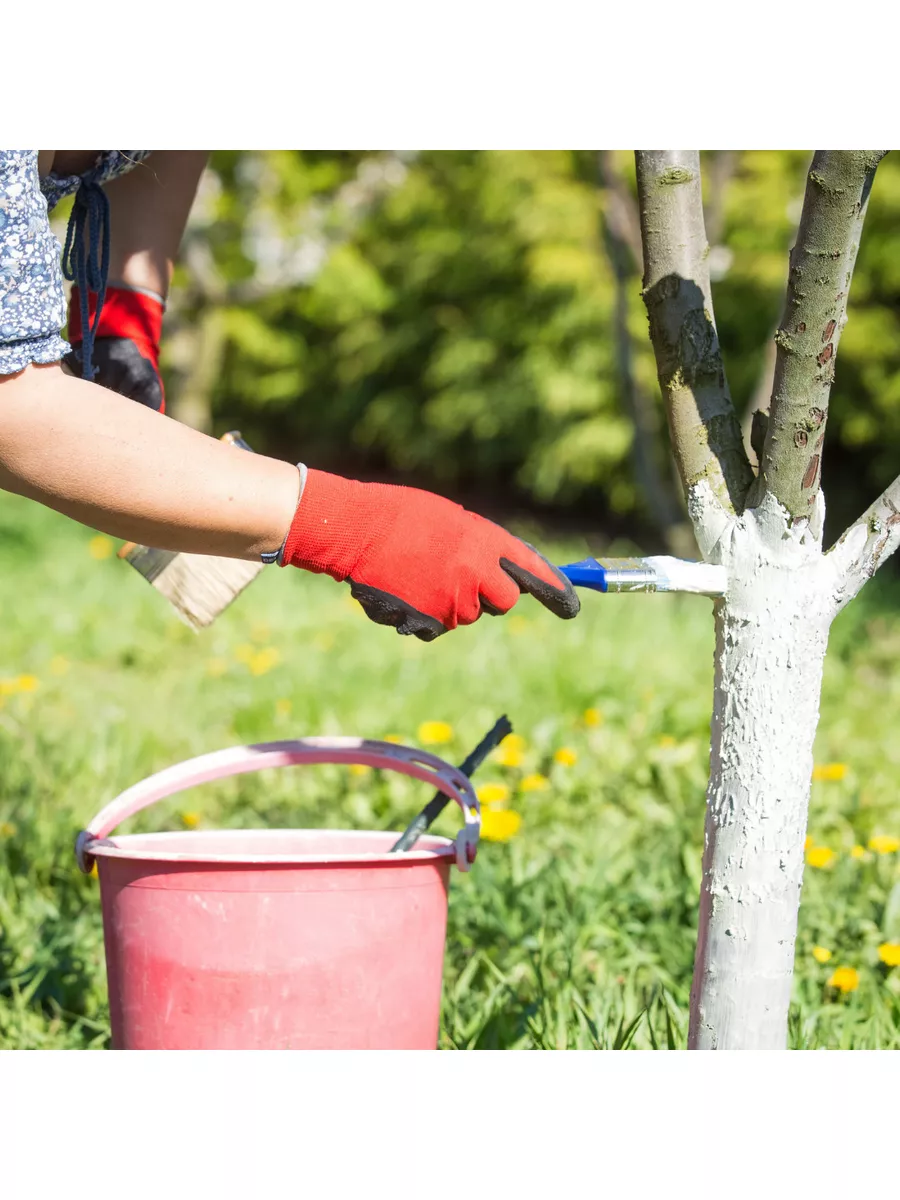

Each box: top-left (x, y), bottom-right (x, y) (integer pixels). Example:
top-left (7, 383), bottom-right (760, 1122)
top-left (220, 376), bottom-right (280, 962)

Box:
top-left (637, 150), bottom-right (900, 1050)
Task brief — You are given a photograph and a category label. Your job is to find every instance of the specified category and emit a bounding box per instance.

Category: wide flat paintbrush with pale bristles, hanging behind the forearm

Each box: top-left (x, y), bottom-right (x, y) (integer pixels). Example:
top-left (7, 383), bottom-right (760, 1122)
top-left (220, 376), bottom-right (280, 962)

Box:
top-left (119, 432), bottom-right (264, 632)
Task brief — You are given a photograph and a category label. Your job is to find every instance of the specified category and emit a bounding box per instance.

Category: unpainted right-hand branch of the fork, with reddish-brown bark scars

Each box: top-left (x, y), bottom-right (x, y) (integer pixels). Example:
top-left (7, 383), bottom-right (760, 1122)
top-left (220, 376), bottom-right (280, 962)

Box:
top-left (754, 150), bottom-right (887, 517)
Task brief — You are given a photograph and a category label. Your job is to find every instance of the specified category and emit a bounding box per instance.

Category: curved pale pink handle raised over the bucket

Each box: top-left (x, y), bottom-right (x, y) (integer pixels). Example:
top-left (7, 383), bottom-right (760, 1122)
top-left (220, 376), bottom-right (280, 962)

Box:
top-left (76, 738), bottom-right (481, 875)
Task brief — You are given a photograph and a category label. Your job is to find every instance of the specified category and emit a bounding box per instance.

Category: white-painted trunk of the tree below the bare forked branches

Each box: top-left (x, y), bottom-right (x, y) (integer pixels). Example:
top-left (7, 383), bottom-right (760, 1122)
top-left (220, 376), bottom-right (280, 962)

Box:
top-left (689, 482), bottom-right (838, 1050)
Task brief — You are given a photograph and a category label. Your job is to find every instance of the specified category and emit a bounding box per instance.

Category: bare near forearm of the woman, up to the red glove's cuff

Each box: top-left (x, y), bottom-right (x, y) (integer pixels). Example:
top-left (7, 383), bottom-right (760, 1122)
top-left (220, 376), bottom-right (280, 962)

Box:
top-left (0, 364), bottom-right (300, 559)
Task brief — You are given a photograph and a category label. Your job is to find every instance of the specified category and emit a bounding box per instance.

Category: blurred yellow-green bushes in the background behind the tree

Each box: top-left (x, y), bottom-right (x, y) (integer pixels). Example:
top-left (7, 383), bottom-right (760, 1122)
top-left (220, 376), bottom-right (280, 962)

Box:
top-left (166, 151), bottom-right (900, 544)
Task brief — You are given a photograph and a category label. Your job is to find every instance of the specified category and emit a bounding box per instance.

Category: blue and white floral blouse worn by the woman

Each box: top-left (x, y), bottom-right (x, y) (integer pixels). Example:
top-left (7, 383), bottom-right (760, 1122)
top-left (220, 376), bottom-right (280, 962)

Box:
top-left (0, 150), bottom-right (150, 376)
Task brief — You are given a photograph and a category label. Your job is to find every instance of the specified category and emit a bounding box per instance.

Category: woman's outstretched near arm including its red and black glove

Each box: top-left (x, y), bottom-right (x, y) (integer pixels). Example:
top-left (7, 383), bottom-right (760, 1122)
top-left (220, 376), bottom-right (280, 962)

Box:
top-left (0, 365), bottom-right (578, 641)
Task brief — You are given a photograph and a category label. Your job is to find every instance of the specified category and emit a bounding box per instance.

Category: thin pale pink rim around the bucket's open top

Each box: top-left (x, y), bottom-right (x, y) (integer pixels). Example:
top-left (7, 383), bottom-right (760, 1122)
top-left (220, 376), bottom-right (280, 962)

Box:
top-left (90, 828), bottom-right (456, 866)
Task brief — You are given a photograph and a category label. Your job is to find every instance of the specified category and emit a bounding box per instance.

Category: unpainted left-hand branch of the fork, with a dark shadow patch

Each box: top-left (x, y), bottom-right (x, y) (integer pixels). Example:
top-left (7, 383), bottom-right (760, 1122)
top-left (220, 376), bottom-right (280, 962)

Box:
top-left (635, 150), bottom-right (754, 512)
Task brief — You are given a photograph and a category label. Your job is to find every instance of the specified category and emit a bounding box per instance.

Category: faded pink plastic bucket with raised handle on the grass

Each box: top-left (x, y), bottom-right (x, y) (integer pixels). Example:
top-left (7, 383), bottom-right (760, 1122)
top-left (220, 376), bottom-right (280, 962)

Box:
top-left (76, 738), bottom-right (480, 1050)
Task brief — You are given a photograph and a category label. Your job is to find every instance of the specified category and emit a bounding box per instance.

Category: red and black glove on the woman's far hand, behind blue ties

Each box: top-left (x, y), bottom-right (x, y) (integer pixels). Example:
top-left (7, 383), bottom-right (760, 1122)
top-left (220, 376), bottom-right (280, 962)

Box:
top-left (66, 286), bottom-right (166, 413)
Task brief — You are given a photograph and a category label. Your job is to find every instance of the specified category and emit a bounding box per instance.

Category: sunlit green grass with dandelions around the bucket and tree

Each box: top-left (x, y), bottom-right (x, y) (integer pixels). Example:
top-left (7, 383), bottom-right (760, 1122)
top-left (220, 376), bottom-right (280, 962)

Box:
top-left (0, 497), bottom-right (900, 1049)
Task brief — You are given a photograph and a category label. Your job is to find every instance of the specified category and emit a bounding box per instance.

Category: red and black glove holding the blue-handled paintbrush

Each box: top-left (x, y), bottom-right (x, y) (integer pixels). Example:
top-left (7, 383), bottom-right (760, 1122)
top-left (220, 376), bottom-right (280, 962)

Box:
top-left (282, 470), bottom-right (580, 642)
